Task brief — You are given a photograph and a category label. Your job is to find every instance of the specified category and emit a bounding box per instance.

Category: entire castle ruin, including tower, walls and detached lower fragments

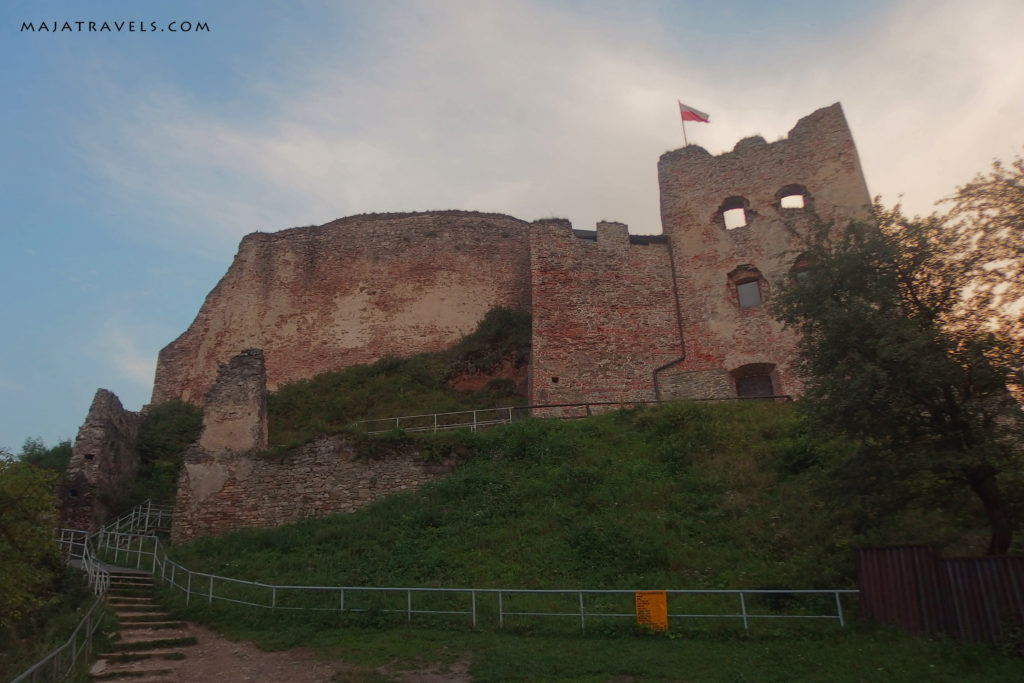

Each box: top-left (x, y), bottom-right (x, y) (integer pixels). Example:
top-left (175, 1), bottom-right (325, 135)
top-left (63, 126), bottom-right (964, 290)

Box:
top-left (65, 103), bottom-right (870, 539)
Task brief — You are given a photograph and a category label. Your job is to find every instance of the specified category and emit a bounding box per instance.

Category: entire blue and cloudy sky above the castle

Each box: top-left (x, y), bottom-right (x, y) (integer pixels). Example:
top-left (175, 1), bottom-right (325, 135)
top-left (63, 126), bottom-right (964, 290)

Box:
top-left (0, 0), bottom-right (1024, 452)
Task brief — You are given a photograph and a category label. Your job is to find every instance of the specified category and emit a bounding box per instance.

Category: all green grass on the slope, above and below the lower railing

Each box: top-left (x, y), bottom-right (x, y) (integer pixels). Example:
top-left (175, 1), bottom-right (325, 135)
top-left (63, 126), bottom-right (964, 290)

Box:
top-left (159, 402), bottom-right (1024, 682)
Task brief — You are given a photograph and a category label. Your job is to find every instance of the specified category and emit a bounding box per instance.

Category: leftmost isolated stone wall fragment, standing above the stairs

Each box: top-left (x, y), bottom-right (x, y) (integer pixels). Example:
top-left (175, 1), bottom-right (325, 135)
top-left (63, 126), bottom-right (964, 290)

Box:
top-left (57, 389), bottom-right (142, 530)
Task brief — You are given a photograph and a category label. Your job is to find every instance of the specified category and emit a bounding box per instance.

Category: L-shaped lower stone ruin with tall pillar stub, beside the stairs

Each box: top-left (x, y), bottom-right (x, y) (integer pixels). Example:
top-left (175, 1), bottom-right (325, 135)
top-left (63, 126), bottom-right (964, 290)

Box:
top-left (171, 349), bottom-right (453, 541)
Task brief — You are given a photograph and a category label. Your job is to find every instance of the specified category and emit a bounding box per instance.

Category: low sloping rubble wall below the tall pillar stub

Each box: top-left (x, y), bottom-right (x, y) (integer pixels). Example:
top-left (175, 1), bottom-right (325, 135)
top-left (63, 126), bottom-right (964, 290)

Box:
top-left (171, 436), bottom-right (454, 542)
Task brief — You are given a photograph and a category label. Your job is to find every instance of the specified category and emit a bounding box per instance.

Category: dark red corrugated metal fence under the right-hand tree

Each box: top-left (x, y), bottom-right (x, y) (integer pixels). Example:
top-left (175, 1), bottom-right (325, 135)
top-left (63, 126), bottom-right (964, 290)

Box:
top-left (856, 546), bottom-right (1024, 642)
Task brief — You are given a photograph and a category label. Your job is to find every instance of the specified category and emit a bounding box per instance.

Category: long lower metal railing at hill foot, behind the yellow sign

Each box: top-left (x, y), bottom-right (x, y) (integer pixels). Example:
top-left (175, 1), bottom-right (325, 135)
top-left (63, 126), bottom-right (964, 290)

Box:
top-left (88, 531), bottom-right (857, 632)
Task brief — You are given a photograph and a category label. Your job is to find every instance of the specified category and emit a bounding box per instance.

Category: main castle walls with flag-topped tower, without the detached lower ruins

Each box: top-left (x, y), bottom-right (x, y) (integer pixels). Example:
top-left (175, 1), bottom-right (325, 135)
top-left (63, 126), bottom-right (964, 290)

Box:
top-left (153, 104), bottom-right (870, 411)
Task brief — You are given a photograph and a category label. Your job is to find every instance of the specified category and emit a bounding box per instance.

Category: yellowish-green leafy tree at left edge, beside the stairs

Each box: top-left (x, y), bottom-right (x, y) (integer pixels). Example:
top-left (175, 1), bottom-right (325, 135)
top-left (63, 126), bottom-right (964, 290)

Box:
top-left (0, 453), bottom-right (61, 643)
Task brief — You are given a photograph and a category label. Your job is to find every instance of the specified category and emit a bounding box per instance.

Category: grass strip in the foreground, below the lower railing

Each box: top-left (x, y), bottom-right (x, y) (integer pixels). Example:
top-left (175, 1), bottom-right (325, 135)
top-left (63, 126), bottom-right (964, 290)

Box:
top-left (148, 612), bottom-right (1024, 683)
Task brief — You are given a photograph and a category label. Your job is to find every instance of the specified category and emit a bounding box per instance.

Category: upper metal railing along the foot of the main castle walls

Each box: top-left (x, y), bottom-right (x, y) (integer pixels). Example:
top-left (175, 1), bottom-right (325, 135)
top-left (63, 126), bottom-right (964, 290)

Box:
top-left (349, 395), bottom-right (792, 434)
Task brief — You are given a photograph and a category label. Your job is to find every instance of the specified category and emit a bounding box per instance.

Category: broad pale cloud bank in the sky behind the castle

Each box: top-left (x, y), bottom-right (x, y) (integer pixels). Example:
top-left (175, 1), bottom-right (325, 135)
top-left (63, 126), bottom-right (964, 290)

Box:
top-left (75, 1), bottom-right (1024, 243)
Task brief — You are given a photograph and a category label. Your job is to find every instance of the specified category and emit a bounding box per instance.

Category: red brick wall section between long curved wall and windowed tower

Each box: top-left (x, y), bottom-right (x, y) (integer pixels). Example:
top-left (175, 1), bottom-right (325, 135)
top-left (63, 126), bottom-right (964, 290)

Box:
top-left (530, 220), bottom-right (681, 403)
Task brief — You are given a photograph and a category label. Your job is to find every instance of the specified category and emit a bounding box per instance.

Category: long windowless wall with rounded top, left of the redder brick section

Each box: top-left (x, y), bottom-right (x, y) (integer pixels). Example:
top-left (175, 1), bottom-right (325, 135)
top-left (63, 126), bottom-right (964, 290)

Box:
top-left (153, 211), bottom-right (529, 403)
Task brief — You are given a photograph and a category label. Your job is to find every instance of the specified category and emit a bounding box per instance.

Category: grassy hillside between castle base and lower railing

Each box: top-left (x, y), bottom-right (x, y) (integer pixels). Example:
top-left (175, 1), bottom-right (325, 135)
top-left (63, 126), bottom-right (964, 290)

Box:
top-left (167, 401), bottom-right (986, 588)
